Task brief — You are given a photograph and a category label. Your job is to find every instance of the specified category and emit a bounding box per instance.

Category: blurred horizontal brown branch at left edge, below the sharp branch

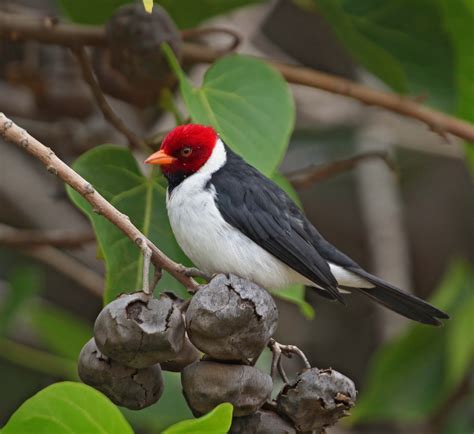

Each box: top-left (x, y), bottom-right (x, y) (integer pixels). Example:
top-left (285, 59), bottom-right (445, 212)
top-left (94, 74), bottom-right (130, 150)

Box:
top-left (0, 223), bottom-right (95, 247)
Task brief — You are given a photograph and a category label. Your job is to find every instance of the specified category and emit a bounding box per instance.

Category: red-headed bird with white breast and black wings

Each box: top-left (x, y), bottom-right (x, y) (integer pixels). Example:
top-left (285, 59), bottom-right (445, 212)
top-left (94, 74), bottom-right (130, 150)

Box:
top-left (145, 124), bottom-right (449, 325)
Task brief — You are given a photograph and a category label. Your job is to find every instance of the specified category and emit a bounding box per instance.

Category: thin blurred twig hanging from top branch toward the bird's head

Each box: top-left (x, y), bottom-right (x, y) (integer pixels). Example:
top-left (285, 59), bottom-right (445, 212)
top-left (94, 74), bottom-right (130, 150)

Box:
top-left (72, 47), bottom-right (145, 149)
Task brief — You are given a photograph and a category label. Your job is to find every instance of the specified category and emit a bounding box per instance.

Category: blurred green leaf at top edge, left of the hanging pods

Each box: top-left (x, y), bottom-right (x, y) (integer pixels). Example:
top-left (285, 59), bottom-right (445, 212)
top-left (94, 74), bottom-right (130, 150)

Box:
top-left (57, 0), bottom-right (131, 25)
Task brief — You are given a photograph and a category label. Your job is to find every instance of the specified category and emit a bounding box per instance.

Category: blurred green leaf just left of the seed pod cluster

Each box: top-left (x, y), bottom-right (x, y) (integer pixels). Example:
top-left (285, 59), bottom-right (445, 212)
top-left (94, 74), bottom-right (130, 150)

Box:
top-left (29, 303), bottom-right (92, 361)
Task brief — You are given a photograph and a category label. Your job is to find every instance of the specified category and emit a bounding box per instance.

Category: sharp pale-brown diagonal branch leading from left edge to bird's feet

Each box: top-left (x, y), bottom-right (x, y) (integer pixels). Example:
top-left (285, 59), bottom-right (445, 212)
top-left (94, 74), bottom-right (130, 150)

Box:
top-left (0, 113), bottom-right (198, 290)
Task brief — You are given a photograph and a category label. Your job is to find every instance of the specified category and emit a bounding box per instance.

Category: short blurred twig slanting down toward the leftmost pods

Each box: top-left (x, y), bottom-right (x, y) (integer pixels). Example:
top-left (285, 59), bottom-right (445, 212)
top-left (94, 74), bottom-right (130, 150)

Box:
top-left (20, 246), bottom-right (104, 298)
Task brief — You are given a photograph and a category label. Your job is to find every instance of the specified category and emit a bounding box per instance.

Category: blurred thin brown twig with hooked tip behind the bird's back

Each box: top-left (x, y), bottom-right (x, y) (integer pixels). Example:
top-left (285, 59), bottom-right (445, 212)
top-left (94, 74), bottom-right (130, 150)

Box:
top-left (286, 151), bottom-right (395, 190)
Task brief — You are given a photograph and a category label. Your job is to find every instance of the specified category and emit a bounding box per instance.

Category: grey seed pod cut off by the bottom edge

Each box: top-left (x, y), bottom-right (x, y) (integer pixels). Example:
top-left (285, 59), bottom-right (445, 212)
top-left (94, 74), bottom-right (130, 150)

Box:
top-left (229, 410), bottom-right (296, 434)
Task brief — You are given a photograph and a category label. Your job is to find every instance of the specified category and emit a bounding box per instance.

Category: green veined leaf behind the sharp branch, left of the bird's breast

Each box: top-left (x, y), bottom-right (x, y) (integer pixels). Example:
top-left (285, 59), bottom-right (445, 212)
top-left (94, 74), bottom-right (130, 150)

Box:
top-left (68, 145), bottom-right (189, 303)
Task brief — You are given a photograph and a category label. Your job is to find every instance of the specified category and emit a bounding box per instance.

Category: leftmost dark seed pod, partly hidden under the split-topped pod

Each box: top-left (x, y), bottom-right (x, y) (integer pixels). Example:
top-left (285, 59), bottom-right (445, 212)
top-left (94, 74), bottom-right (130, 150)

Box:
top-left (78, 338), bottom-right (164, 410)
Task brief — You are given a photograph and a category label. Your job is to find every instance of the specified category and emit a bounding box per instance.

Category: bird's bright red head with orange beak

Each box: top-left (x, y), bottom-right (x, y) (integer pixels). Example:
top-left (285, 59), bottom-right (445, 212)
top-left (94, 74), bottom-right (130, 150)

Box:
top-left (145, 124), bottom-right (218, 174)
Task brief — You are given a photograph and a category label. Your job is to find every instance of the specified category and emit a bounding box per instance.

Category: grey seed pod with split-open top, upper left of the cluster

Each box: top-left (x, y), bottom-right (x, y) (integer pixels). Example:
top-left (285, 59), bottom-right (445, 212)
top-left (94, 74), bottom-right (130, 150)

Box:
top-left (94, 292), bottom-right (184, 368)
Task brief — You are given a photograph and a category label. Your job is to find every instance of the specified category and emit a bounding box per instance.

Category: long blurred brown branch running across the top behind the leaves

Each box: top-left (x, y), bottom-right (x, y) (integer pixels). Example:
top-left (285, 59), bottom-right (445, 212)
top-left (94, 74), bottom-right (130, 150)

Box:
top-left (0, 12), bottom-right (474, 143)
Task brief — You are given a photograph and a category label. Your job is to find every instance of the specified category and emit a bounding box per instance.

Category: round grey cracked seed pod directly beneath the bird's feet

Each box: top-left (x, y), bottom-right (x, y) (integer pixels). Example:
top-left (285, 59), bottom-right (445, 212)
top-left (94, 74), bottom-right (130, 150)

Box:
top-left (186, 274), bottom-right (278, 363)
